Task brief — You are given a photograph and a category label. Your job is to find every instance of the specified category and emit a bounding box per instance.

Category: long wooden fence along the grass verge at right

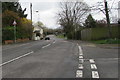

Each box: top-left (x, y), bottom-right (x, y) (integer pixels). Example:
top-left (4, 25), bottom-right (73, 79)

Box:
top-left (81, 27), bottom-right (120, 40)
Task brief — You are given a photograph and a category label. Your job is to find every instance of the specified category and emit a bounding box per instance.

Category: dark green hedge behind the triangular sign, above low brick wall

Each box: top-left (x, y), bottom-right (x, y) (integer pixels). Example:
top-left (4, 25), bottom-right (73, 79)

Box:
top-left (2, 26), bottom-right (31, 43)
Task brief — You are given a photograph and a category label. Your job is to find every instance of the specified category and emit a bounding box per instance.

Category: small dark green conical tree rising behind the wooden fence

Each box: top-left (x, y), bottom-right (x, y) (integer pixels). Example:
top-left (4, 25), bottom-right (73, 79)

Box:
top-left (85, 14), bottom-right (96, 28)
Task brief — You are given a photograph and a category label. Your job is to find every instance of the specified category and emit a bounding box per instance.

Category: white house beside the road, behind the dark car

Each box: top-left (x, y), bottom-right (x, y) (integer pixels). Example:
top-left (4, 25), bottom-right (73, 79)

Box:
top-left (33, 26), bottom-right (43, 40)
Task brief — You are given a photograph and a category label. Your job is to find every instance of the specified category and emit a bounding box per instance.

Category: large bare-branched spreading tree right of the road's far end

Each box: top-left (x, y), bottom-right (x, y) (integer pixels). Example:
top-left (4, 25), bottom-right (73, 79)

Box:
top-left (58, 1), bottom-right (89, 38)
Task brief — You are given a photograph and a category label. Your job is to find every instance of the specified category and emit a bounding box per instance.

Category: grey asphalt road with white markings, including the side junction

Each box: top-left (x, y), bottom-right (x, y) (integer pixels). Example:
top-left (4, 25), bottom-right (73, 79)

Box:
top-left (0, 35), bottom-right (118, 78)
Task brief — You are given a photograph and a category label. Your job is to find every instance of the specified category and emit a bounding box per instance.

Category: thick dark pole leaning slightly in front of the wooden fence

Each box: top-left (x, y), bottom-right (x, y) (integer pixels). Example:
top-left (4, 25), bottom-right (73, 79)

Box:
top-left (104, 0), bottom-right (112, 38)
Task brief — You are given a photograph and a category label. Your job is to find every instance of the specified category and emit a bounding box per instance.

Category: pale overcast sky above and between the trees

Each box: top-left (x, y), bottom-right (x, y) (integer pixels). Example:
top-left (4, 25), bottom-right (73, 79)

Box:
top-left (19, 0), bottom-right (119, 28)
